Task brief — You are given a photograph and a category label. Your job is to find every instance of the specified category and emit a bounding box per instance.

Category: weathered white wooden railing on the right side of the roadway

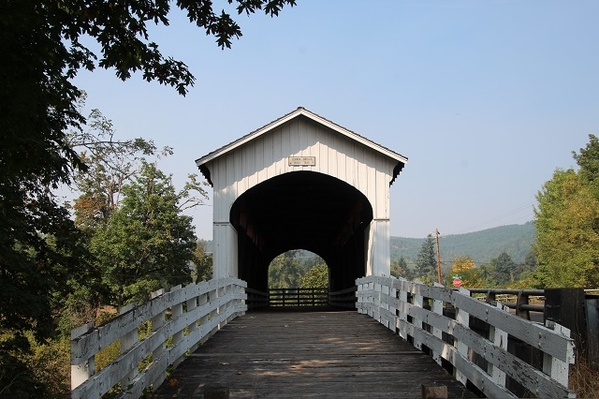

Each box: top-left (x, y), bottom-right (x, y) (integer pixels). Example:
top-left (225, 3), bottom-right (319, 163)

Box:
top-left (356, 276), bottom-right (574, 398)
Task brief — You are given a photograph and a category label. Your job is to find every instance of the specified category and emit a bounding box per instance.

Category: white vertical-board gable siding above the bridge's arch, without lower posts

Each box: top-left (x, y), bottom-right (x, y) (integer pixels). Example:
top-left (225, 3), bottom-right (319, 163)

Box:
top-left (207, 118), bottom-right (397, 222)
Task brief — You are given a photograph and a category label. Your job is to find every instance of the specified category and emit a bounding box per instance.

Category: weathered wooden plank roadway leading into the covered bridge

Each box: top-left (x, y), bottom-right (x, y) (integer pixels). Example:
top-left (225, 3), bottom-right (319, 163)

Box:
top-left (153, 311), bottom-right (476, 399)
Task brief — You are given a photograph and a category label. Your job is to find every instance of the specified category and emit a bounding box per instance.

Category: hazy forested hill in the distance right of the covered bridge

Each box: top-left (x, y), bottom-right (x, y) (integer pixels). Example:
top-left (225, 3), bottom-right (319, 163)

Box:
top-left (391, 222), bottom-right (536, 266)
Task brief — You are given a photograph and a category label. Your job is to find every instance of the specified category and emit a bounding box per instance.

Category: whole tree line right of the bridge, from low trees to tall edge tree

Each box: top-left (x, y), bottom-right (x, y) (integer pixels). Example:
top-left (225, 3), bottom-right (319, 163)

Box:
top-left (391, 134), bottom-right (599, 288)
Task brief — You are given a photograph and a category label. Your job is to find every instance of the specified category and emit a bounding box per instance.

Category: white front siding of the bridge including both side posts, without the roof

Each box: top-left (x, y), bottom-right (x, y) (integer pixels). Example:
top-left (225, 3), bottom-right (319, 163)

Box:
top-left (206, 118), bottom-right (398, 277)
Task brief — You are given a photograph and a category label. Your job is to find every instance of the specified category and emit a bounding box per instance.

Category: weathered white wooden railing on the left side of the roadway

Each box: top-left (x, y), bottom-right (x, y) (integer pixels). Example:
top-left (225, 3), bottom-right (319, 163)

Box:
top-left (71, 278), bottom-right (247, 399)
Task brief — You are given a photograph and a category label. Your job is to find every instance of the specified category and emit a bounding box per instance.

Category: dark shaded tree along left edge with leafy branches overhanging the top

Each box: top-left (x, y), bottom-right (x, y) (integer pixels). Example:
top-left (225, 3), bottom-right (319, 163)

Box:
top-left (0, 0), bottom-right (295, 397)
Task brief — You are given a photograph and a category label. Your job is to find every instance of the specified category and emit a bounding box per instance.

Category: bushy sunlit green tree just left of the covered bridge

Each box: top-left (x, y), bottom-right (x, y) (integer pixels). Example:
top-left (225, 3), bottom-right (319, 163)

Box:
top-left (91, 162), bottom-right (197, 306)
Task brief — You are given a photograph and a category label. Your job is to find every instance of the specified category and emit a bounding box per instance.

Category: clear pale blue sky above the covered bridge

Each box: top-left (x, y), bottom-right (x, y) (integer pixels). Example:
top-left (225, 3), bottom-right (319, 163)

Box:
top-left (76, 0), bottom-right (599, 239)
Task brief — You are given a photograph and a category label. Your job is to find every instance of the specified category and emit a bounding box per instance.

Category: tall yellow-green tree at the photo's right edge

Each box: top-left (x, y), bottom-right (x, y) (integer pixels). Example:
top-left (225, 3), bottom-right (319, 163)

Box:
top-left (535, 135), bottom-right (599, 288)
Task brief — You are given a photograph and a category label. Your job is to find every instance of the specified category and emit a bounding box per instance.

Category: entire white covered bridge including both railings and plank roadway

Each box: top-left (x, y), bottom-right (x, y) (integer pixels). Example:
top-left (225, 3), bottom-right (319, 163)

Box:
top-left (71, 108), bottom-right (574, 399)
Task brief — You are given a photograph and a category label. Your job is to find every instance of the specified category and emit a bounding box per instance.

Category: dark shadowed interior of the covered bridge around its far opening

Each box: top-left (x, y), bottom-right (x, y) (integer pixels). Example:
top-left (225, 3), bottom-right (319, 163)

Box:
top-left (230, 171), bottom-right (372, 291)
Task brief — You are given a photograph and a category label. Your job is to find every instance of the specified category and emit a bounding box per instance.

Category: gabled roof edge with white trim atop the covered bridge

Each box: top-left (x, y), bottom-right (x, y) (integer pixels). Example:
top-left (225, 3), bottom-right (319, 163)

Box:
top-left (195, 107), bottom-right (408, 184)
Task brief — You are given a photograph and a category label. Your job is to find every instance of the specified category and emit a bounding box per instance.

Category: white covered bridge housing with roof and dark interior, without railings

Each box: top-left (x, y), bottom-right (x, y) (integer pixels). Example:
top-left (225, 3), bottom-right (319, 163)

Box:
top-left (196, 107), bottom-right (407, 291)
